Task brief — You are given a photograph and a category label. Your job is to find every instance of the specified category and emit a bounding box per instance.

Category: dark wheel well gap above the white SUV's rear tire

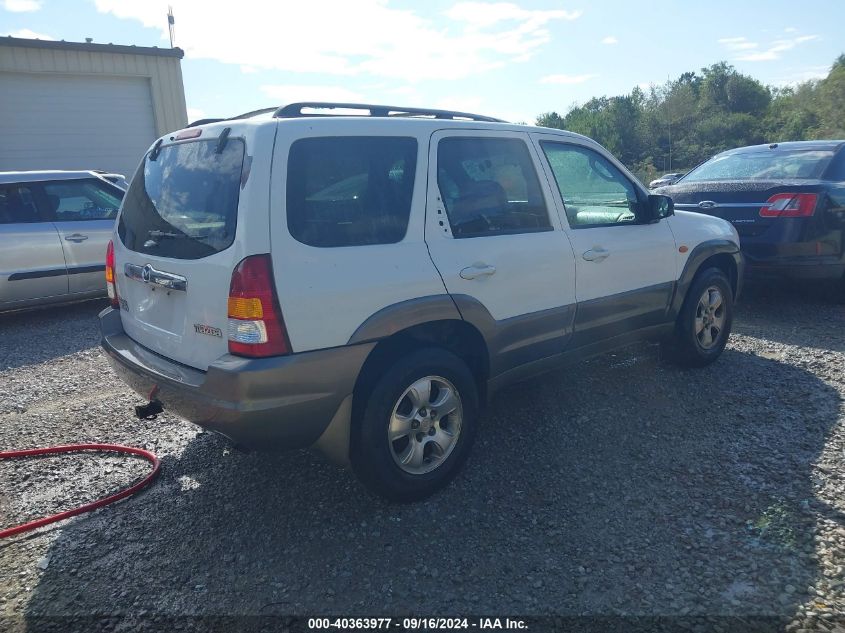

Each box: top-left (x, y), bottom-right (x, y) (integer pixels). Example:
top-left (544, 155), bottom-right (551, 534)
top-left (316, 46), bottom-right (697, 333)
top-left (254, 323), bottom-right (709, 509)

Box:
top-left (352, 319), bottom-right (490, 420)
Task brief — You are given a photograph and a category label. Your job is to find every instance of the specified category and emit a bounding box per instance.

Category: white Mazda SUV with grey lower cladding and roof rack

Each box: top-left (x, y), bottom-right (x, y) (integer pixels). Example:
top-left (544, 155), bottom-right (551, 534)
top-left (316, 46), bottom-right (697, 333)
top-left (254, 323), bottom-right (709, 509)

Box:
top-left (100, 103), bottom-right (743, 500)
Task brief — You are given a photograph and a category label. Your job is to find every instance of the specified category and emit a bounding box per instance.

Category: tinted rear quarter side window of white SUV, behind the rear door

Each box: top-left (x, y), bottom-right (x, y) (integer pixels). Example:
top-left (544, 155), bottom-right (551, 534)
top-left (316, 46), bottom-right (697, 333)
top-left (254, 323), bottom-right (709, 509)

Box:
top-left (287, 136), bottom-right (417, 247)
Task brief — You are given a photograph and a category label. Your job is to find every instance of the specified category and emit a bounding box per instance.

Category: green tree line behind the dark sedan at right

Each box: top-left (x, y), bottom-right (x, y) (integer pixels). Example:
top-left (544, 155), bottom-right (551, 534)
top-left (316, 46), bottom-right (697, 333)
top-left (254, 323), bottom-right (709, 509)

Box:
top-left (537, 54), bottom-right (845, 183)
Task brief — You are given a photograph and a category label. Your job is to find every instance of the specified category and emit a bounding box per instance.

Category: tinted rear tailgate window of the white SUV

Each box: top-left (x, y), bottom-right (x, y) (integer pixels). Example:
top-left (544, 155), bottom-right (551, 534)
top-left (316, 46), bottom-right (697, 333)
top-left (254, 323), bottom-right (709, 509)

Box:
top-left (118, 138), bottom-right (244, 259)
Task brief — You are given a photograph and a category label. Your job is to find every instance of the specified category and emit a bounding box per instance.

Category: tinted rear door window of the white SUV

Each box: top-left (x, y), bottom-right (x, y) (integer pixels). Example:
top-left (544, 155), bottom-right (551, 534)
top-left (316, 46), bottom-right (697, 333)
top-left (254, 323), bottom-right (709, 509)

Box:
top-left (437, 137), bottom-right (552, 238)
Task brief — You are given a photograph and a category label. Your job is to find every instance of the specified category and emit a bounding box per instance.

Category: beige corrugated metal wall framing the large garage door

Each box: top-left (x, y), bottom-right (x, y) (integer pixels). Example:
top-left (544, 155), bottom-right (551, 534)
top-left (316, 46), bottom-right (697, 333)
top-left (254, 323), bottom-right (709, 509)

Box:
top-left (0, 46), bottom-right (188, 136)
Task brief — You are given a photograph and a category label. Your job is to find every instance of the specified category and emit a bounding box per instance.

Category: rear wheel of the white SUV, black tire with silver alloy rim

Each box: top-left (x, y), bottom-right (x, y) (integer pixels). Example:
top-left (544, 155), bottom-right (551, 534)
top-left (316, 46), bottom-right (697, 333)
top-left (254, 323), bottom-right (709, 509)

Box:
top-left (350, 348), bottom-right (478, 502)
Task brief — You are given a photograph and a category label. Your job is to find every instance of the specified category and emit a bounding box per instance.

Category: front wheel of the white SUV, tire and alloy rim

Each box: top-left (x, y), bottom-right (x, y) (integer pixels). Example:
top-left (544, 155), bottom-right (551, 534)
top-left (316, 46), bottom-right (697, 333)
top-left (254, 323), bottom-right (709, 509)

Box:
top-left (664, 268), bottom-right (733, 367)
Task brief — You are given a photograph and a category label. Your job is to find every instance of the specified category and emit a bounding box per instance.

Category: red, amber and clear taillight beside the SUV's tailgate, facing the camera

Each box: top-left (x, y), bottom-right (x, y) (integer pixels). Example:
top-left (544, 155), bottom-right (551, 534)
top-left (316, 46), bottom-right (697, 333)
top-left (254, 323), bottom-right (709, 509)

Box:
top-left (228, 255), bottom-right (290, 357)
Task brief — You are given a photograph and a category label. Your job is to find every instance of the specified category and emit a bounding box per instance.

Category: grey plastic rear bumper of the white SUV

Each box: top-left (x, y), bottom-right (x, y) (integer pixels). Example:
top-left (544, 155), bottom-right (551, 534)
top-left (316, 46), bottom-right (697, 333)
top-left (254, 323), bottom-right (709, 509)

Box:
top-left (100, 308), bottom-right (375, 449)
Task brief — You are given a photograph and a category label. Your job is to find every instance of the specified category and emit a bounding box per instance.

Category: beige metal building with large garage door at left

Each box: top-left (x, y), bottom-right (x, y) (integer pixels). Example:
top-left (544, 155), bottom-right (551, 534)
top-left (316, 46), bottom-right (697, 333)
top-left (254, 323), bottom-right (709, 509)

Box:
top-left (0, 37), bottom-right (188, 177)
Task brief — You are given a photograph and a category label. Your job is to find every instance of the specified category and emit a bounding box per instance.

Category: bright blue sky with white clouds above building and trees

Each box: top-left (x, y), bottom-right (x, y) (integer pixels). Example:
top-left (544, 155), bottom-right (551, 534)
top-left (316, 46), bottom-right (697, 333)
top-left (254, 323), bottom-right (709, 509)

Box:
top-left (0, 0), bottom-right (845, 123)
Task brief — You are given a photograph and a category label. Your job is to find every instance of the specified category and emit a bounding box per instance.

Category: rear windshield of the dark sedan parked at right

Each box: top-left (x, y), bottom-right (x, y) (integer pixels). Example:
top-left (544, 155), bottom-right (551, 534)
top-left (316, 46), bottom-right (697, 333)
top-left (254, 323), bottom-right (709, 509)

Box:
top-left (680, 150), bottom-right (833, 183)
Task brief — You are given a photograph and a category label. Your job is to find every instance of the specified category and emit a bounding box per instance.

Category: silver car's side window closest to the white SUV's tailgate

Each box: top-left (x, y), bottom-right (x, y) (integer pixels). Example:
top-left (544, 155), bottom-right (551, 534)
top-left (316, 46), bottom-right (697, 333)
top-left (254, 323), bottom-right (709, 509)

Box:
top-left (43, 180), bottom-right (123, 222)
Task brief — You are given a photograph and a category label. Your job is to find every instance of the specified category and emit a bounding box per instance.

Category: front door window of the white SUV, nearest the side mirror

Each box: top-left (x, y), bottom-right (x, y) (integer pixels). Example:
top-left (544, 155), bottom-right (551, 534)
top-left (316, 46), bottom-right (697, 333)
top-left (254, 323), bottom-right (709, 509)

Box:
top-left (541, 141), bottom-right (638, 229)
